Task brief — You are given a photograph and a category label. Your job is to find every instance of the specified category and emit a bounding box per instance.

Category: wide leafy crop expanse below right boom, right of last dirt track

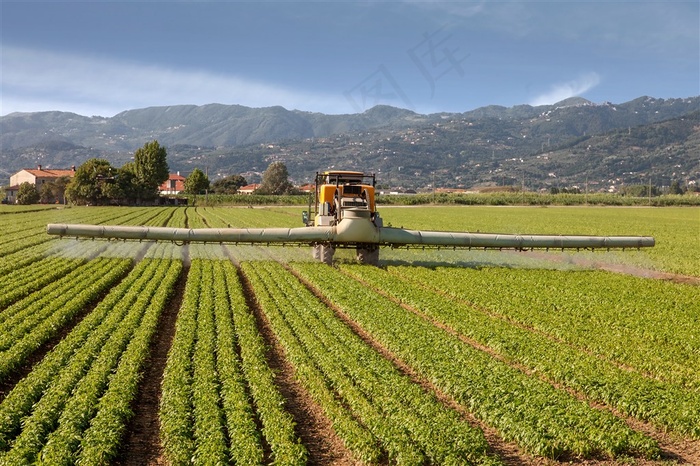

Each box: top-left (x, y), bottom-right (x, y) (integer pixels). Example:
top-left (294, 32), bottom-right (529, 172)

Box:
top-left (343, 265), bottom-right (700, 437)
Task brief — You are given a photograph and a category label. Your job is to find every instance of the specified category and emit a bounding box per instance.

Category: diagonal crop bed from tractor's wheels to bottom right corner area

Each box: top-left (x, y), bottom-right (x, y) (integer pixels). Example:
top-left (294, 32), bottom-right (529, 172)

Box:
top-left (294, 263), bottom-right (660, 458)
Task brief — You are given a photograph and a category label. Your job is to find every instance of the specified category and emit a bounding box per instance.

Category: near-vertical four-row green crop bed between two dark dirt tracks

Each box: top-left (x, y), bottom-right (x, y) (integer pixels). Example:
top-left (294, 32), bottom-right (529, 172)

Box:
top-left (160, 259), bottom-right (306, 465)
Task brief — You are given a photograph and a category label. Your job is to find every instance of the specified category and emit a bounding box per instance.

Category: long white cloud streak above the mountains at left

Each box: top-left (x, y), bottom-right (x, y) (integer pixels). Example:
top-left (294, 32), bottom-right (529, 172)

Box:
top-left (0, 46), bottom-right (350, 116)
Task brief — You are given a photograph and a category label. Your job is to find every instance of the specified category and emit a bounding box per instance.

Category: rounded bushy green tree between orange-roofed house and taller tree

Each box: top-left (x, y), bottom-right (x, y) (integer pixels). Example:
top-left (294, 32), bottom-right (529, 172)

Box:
top-left (66, 159), bottom-right (117, 205)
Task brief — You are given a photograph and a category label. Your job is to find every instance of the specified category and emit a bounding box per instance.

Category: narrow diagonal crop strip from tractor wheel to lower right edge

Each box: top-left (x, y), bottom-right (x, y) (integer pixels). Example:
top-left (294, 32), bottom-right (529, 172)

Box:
top-left (343, 265), bottom-right (700, 438)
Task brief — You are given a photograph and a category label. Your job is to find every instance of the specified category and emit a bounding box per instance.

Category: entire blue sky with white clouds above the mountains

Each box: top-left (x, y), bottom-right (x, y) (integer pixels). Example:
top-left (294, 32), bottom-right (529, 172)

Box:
top-left (0, 0), bottom-right (700, 117)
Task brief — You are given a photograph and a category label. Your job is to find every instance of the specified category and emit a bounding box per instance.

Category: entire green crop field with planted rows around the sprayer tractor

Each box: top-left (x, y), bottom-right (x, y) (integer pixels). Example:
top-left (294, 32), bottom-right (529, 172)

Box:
top-left (0, 206), bottom-right (700, 466)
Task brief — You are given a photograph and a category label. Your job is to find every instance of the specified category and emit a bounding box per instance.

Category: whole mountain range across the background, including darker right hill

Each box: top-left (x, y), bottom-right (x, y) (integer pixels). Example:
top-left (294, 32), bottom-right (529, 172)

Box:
top-left (0, 96), bottom-right (700, 190)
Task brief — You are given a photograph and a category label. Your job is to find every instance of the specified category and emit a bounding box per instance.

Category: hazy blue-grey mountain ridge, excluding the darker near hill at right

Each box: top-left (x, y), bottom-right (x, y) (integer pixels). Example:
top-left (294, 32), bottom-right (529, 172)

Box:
top-left (0, 96), bottom-right (700, 190)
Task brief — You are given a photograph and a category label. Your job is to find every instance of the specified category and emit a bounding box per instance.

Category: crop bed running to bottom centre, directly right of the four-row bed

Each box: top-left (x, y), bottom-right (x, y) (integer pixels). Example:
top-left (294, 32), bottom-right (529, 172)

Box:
top-left (243, 262), bottom-right (498, 464)
